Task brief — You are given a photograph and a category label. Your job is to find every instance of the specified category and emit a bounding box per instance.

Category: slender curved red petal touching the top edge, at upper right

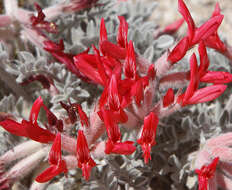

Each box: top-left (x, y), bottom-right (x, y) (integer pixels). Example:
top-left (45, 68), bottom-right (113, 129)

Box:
top-left (178, 0), bottom-right (195, 42)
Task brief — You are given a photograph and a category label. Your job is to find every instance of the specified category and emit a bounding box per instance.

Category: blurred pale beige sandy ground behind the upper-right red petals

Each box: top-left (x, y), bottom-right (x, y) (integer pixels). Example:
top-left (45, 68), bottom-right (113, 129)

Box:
top-left (148, 0), bottom-right (232, 45)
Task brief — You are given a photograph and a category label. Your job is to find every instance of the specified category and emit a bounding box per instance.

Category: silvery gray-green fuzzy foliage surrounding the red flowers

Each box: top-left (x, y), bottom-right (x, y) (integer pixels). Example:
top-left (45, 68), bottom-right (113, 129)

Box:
top-left (0, 0), bottom-right (232, 190)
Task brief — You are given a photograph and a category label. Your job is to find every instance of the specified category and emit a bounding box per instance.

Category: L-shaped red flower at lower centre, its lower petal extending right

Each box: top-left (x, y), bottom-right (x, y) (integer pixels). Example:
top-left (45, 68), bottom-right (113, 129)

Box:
top-left (98, 109), bottom-right (136, 155)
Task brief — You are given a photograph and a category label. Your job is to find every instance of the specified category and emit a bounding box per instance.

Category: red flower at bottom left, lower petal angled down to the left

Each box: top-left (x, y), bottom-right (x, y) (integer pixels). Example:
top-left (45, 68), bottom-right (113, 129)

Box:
top-left (35, 133), bottom-right (68, 183)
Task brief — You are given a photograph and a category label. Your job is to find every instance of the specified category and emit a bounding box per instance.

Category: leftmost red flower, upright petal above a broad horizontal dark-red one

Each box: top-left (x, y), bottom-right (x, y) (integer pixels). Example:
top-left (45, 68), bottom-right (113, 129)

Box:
top-left (0, 97), bottom-right (55, 143)
